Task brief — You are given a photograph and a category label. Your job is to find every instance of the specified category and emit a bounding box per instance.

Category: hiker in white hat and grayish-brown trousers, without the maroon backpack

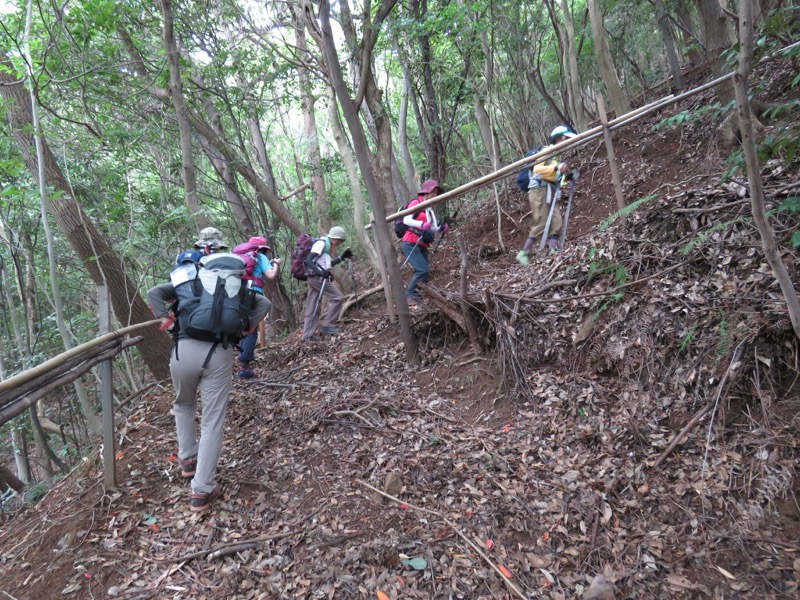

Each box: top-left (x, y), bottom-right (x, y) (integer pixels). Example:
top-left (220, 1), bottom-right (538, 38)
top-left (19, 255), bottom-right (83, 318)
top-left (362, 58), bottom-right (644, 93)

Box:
top-left (300, 226), bottom-right (353, 342)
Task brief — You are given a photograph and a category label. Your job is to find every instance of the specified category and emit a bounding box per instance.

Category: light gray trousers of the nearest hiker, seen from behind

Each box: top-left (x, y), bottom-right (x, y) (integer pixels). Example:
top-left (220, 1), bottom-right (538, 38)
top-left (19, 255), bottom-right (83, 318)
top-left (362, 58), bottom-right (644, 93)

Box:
top-left (169, 338), bottom-right (234, 494)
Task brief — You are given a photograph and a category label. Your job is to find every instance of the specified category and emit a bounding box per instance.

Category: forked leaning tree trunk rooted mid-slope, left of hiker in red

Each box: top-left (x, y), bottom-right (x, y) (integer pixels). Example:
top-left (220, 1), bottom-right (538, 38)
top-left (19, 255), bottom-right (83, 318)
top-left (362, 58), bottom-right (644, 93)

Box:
top-left (319, 0), bottom-right (419, 362)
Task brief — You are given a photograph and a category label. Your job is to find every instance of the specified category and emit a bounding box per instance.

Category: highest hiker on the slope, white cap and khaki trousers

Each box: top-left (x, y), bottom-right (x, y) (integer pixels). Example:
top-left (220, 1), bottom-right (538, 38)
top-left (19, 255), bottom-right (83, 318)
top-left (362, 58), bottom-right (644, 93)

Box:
top-left (517, 125), bottom-right (577, 265)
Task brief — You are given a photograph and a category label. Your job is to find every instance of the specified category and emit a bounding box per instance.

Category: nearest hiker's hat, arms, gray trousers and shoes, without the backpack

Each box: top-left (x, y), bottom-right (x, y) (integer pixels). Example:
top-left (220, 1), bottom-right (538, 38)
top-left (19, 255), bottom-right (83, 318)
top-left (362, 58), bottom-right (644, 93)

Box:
top-left (147, 228), bottom-right (271, 511)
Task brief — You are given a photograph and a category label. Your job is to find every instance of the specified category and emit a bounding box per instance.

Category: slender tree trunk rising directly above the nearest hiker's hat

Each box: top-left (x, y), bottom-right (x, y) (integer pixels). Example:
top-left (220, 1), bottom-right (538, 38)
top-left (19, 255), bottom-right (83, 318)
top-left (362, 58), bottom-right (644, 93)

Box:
top-left (160, 0), bottom-right (211, 231)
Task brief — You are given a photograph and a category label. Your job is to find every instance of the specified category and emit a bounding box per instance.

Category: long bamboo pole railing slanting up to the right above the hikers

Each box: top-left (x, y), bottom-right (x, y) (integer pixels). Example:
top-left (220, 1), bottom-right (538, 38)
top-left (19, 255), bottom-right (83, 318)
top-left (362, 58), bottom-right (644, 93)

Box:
top-left (365, 73), bottom-right (734, 229)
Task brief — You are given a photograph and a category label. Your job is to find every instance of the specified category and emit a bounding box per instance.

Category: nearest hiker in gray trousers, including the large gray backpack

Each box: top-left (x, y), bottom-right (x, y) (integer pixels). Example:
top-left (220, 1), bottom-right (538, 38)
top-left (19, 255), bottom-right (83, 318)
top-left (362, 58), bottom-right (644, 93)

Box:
top-left (147, 227), bottom-right (272, 511)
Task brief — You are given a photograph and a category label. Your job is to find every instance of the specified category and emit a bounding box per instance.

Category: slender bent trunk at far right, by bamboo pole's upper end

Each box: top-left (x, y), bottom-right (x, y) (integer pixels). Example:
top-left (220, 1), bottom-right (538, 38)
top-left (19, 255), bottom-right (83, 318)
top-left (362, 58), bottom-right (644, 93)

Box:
top-left (733, 0), bottom-right (800, 338)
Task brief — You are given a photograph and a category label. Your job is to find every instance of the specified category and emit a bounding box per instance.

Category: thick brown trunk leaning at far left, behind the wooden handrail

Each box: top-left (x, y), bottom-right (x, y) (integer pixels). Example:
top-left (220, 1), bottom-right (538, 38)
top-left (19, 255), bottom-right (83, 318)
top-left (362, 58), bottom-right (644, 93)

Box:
top-left (0, 60), bottom-right (171, 379)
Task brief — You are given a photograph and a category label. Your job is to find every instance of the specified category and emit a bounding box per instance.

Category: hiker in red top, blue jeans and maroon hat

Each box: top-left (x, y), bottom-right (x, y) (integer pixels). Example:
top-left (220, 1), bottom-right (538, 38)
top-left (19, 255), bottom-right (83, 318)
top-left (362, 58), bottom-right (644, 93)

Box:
top-left (403, 179), bottom-right (450, 306)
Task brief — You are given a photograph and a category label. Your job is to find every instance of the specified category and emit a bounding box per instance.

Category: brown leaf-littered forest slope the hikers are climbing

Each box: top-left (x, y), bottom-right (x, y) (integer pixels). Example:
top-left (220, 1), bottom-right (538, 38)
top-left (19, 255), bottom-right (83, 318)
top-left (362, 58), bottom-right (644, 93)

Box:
top-left (0, 64), bottom-right (800, 600)
